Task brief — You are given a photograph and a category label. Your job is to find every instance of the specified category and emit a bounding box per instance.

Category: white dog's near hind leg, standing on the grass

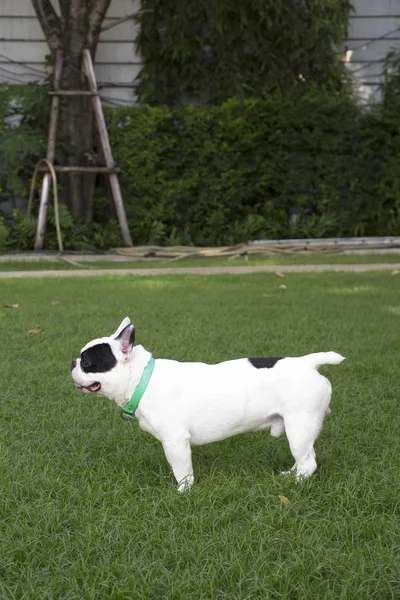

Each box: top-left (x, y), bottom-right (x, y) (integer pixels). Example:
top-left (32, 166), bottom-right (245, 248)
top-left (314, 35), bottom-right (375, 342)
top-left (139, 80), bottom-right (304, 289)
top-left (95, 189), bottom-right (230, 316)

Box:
top-left (285, 413), bottom-right (324, 479)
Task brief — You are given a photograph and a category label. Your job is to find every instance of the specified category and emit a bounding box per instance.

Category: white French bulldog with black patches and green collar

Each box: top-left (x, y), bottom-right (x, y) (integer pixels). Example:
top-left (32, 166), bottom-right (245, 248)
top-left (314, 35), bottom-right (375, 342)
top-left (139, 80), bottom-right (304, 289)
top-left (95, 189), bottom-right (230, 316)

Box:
top-left (71, 317), bottom-right (344, 492)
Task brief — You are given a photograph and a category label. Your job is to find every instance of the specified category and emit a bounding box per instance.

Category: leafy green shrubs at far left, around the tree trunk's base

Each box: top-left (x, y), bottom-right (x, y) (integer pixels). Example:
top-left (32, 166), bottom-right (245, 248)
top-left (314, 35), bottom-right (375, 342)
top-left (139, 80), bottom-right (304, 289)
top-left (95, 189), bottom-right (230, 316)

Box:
top-left (0, 83), bottom-right (122, 250)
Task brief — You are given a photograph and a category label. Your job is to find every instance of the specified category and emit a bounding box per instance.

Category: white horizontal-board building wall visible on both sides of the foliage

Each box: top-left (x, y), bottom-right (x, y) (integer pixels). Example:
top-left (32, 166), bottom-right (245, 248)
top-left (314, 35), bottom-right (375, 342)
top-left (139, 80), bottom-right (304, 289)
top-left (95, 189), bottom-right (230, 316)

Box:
top-left (0, 0), bottom-right (400, 106)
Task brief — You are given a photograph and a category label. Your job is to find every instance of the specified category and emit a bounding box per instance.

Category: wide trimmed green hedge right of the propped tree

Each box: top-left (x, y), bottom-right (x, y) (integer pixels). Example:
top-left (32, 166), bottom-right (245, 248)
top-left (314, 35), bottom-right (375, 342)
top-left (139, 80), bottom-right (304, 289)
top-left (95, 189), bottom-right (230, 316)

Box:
top-left (108, 90), bottom-right (400, 245)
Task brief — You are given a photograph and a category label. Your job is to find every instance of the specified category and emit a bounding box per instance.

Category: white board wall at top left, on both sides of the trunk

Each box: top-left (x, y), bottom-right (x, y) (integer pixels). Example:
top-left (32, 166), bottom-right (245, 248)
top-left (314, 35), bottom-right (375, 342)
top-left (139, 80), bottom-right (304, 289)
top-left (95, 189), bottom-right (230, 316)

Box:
top-left (0, 0), bottom-right (141, 105)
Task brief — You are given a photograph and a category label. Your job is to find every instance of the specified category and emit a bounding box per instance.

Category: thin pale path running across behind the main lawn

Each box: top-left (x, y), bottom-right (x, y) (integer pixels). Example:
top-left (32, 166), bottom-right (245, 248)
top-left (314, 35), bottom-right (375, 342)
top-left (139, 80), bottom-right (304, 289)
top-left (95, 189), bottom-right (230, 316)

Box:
top-left (0, 263), bottom-right (400, 279)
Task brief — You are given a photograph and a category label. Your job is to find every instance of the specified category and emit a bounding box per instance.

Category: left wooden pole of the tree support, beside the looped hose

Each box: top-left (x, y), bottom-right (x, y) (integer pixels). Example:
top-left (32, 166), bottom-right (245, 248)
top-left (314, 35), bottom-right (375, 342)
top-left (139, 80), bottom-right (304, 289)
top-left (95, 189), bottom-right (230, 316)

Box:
top-left (34, 50), bottom-right (63, 250)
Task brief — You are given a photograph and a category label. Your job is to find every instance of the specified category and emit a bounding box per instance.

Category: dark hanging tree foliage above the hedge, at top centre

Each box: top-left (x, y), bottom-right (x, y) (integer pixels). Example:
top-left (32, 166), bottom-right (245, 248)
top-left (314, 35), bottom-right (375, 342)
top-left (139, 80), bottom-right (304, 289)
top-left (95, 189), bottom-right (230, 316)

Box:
top-left (137, 0), bottom-right (351, 105)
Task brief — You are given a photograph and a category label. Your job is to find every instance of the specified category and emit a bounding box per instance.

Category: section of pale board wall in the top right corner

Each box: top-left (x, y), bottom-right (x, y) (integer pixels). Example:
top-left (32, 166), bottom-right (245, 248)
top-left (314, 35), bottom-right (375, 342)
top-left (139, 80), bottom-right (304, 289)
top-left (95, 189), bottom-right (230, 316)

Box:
top-left (346, 0), bottom-right (400, 100)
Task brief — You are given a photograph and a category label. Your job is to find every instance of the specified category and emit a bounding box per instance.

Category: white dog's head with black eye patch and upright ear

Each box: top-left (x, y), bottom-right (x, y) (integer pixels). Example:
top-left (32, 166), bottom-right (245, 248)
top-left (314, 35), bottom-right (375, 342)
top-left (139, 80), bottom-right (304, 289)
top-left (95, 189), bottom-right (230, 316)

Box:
top-left (71, 317), bottom-right (135, 399)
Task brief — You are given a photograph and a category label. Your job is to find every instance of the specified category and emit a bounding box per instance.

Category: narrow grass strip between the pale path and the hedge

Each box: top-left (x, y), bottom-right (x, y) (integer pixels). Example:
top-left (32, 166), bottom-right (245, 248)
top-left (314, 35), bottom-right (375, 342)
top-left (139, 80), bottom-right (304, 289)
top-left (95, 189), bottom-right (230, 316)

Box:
top-left (0, 252), bottom-right (400, 272)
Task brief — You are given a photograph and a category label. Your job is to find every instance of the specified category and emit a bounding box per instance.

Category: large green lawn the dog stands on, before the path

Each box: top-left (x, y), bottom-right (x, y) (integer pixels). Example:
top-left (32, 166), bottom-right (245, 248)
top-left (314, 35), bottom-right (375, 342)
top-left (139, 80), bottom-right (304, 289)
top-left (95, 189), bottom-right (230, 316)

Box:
top-left (0, 272), bottom-right (400, 600)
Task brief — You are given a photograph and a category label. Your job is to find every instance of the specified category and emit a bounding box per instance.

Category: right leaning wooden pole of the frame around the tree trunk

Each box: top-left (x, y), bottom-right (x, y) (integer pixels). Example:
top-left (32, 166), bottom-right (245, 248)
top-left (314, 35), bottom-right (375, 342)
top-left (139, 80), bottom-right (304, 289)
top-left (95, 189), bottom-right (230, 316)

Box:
top-left (83, 50), bottom-right (133, 247)
